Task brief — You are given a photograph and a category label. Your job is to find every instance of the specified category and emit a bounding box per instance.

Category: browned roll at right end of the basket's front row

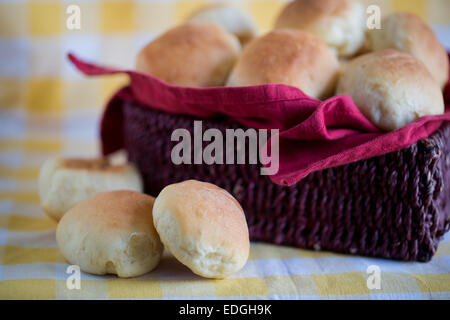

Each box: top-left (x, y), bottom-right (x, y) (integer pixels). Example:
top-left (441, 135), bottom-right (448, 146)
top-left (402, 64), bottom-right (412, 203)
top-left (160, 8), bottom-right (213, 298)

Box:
top-left (337, 49), bottom-right (444, 131)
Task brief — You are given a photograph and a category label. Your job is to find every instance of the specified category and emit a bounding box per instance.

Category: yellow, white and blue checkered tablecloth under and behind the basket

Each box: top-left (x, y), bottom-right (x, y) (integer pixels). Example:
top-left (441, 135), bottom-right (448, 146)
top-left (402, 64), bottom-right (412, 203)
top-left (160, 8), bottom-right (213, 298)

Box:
top-left (0, 0), bottom-right (450, 299)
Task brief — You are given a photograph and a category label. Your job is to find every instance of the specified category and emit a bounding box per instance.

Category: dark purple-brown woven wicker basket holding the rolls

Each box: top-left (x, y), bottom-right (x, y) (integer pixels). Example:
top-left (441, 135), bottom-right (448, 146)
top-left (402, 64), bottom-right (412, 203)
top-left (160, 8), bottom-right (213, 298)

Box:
top-left (124, 103), bottom-right (450, 261)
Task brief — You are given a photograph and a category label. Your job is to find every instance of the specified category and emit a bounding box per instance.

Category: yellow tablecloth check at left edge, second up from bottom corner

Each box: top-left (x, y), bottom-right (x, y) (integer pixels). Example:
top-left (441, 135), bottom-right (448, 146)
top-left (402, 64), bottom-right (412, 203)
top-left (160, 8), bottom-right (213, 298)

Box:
top-left (0, 245), bottom-right (66, 265)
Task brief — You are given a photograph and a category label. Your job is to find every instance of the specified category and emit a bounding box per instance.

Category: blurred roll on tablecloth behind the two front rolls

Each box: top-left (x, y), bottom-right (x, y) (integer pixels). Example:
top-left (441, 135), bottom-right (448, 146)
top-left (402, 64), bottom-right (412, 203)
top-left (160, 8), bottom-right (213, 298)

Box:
top-left (38, 158), bottom-right (142, 221)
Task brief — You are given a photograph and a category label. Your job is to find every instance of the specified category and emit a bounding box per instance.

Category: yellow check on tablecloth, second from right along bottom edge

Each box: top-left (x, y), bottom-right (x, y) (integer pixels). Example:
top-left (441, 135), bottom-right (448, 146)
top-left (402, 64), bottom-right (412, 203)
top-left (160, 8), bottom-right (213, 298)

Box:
top-left (312, 272), bottom-right (370, 295)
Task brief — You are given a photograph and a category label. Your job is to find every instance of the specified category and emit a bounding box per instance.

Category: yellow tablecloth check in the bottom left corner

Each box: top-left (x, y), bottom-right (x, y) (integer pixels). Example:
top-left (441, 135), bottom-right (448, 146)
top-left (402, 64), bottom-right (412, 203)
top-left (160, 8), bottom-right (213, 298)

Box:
top-left (0, 279), bottom-right (56, 300)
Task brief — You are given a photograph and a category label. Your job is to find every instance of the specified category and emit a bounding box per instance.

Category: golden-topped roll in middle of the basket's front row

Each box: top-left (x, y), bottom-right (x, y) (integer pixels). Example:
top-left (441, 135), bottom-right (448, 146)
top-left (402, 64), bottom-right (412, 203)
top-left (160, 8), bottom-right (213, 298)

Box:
top-left (227, 29), bottom-right (339, 99)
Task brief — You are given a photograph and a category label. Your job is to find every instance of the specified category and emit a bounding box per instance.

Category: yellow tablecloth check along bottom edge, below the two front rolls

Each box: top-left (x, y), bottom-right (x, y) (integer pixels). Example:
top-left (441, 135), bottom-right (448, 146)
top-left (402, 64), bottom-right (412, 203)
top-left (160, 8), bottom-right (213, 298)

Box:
top-left (107, 279), bottom-right (162, 299)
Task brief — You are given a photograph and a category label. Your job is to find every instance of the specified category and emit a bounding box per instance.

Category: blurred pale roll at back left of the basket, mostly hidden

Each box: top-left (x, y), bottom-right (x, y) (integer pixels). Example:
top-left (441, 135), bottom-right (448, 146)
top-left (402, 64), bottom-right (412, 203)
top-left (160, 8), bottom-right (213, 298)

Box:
top-left (188, 3), bottom-right (257, 45)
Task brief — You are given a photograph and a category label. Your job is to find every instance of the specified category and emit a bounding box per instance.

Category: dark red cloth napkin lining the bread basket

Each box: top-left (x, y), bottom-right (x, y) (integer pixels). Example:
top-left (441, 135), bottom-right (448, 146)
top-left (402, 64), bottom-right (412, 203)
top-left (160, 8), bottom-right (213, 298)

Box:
top-left (69, 54), bottom-right (450, 185)
